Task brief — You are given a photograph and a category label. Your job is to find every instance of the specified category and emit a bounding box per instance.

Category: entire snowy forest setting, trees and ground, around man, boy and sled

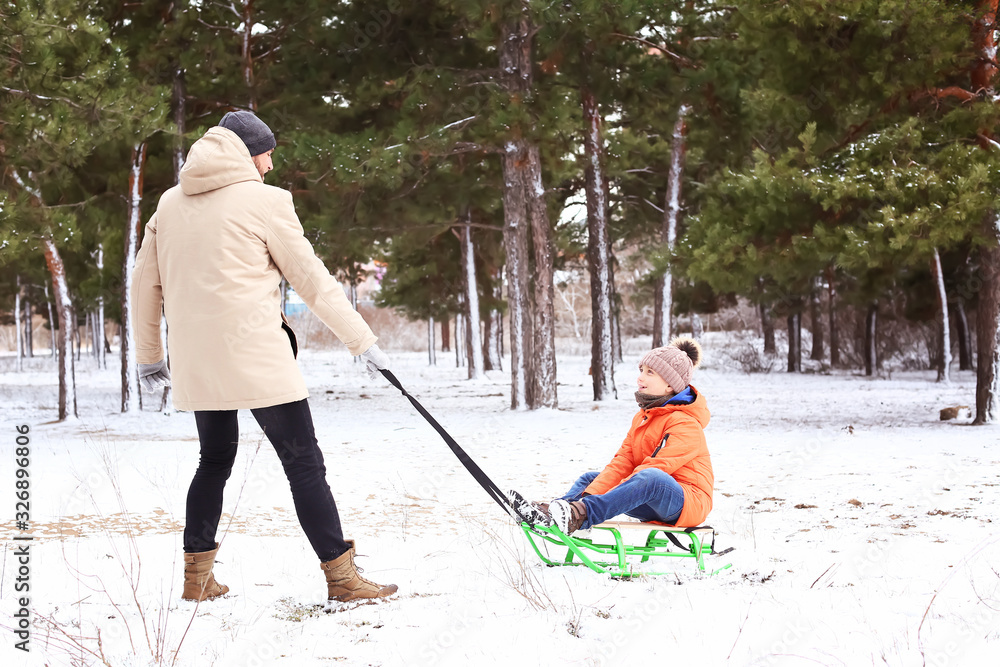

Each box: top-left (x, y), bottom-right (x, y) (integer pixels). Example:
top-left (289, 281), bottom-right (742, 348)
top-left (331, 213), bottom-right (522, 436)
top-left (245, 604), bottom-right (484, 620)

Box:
top-left (0, 0), bottom-right (1000, 667)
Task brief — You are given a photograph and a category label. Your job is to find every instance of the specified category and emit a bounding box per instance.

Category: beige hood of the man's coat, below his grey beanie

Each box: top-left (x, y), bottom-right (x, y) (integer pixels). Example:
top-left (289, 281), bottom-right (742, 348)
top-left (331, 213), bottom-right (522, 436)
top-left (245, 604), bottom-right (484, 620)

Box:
top-left (179, 127), bottom-right (264, 195)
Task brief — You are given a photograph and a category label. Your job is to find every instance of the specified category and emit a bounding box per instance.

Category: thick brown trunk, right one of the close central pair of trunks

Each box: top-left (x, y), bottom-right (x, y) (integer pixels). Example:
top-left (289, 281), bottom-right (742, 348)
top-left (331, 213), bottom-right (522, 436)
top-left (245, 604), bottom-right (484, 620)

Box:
top-left (524, 143), bottom-right (559, 410)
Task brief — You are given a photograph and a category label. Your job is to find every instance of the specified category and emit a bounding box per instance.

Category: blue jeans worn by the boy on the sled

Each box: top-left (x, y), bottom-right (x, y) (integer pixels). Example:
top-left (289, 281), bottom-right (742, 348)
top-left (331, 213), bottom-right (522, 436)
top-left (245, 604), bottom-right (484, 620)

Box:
top-left (562, 468), bottom-right (684, 530)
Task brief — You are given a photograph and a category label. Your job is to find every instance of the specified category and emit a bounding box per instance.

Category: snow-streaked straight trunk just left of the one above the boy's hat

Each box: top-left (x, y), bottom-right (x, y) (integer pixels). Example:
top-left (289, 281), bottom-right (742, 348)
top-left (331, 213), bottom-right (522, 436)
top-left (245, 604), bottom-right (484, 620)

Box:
top-left (582, 82), bottom-right (618, 401)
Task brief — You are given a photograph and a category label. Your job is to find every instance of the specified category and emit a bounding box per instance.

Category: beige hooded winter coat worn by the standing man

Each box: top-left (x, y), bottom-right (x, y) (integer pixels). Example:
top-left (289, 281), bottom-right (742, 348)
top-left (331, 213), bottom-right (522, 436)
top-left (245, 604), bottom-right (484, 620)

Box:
top-left (131, 127), bottom-right (376, 410)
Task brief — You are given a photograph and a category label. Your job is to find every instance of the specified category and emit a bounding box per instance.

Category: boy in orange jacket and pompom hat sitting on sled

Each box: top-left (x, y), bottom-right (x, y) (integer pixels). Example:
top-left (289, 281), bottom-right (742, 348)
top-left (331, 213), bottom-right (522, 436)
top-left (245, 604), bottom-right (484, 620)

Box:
top-left (510, 338), bottom-right (714, 535)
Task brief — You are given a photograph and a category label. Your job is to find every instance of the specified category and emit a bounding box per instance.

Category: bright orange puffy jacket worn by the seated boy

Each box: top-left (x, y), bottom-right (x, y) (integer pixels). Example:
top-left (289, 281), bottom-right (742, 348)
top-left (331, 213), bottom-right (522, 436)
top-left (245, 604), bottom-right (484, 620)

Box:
top-left (586, 387), bottom-right (715, 527)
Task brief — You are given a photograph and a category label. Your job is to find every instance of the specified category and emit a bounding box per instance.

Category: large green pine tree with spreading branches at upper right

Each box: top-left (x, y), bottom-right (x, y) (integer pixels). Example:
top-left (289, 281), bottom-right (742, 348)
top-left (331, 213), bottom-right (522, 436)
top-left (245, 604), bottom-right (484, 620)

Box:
top-left (686, 0), bottom-right (996, 380)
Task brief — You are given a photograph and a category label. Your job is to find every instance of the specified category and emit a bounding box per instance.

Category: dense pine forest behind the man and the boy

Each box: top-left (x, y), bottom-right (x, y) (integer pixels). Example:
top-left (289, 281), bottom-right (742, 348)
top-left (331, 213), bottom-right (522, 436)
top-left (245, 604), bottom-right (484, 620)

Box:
top-left (0, 2), bottom-right (1000, 423)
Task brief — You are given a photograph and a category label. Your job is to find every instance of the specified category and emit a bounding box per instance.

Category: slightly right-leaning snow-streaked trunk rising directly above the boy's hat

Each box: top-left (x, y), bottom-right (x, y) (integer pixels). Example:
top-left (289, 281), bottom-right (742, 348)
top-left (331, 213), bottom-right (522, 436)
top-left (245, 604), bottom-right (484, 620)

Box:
top-left (653, 104), bottom-right (691, 347)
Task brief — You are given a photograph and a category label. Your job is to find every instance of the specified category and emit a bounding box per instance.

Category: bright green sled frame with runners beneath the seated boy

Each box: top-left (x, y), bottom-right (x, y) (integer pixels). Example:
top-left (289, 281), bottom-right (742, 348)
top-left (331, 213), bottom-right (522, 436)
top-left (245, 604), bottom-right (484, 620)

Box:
top-left (521, 521), bottom-right (732, 577)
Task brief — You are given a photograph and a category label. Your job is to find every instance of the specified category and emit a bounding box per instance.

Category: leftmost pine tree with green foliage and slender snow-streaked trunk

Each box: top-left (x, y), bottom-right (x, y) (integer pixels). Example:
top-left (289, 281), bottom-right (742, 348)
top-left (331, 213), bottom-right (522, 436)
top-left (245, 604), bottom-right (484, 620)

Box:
top-left (0, 0), bottom-right (164, 419)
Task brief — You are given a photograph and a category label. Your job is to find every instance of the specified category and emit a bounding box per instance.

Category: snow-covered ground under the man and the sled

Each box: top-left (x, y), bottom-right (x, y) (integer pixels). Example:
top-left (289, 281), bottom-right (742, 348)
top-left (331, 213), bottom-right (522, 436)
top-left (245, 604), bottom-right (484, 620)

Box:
top-left (0, 346), bottom-right (1000, 667)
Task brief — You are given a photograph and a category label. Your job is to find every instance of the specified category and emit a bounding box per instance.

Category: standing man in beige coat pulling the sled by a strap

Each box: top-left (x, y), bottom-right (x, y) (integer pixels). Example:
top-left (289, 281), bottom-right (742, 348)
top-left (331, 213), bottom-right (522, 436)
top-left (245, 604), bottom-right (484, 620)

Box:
top-left (131, 111), bottom-right (396, 601)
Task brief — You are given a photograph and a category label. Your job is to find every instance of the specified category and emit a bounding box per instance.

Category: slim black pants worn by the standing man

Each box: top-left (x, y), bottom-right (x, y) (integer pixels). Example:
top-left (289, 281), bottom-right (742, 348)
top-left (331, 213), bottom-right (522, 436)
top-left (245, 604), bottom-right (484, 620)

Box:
top-left (184, 399), bottom-right (348, 561)
